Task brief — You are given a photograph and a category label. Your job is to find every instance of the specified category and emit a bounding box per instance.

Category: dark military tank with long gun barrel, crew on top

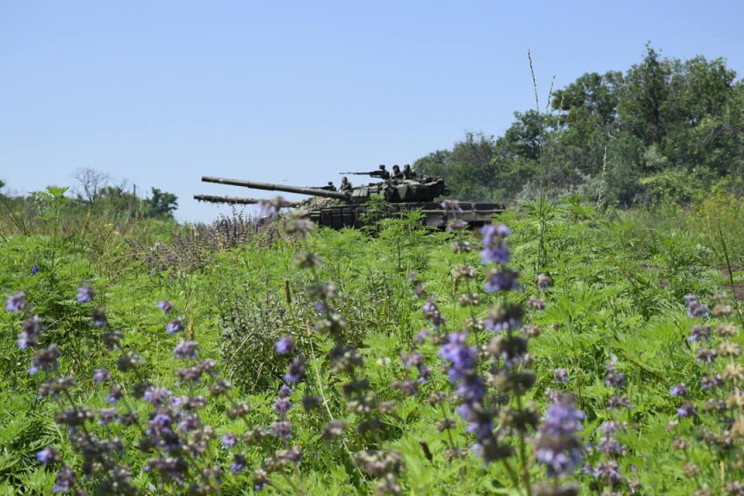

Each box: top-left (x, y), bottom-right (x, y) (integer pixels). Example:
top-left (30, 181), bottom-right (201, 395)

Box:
top-left (194, 171), bottom-right (505, 229)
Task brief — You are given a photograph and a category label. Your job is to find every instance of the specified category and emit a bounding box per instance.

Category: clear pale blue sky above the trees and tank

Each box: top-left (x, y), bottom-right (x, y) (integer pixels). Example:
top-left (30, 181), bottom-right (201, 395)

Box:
top-left (0, 0), bottom-right (744, 222)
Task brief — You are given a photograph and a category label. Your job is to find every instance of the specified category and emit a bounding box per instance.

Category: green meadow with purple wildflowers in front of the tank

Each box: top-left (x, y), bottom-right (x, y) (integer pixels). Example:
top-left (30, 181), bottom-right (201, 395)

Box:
top-left (0, 191), bottom-right (744, 496)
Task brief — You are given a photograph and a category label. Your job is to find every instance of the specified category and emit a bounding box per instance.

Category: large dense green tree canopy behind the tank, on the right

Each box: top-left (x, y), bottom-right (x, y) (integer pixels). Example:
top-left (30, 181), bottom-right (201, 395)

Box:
top-left (414, 45), bottom-right (744, 206)
